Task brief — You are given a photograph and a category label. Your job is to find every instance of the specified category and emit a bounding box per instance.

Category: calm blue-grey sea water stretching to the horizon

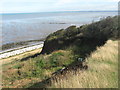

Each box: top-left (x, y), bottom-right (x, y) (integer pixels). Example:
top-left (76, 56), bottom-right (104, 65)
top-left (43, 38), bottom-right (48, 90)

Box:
top-left (0, 12), bottom-right (117, 44)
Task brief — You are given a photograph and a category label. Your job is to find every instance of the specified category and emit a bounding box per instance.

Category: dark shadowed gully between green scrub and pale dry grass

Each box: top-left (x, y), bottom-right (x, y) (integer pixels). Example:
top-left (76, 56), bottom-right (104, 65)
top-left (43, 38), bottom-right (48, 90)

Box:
top-left (28, 38), bottom-right (107, 88)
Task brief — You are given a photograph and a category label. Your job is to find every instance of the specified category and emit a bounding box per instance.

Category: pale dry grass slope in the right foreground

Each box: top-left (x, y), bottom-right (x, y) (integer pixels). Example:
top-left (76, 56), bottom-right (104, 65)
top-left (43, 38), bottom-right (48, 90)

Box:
top-left (50, 40), bottom-right (118, 88)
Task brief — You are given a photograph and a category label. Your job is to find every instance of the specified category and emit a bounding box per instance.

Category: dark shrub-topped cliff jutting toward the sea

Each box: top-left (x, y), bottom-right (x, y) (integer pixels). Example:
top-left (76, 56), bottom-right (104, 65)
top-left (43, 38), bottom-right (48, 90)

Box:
top-left (41, 16), bottom-right (118, 54)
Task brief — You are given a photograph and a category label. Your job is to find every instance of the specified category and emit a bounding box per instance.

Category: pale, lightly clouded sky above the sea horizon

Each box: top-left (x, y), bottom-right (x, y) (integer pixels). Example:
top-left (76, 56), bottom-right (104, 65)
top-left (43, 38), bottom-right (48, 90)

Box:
top-left (0, 0), bottom-right (119, 13)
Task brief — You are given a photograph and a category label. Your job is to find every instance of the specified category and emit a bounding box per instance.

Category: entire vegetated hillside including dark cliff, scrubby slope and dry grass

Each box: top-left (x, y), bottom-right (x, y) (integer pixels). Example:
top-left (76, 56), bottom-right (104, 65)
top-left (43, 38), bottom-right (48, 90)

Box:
top-left (2, 16), bottom-right (118, 88)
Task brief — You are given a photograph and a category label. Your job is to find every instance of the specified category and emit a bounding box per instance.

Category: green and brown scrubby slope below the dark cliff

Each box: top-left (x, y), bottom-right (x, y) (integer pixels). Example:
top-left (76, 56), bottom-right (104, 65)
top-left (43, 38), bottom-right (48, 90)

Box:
top-left (2, 50), bottom-right (73, 88)
